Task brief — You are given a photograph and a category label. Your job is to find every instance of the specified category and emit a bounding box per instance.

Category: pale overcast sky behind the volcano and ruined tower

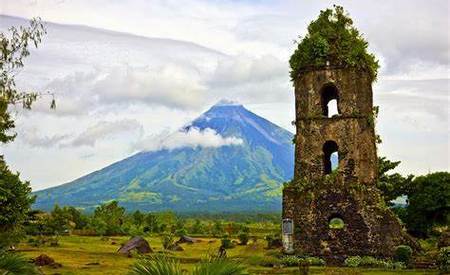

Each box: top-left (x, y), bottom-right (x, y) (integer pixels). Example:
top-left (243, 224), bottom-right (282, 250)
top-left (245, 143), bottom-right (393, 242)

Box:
top-left (0, 0), bottom-right (450, 190)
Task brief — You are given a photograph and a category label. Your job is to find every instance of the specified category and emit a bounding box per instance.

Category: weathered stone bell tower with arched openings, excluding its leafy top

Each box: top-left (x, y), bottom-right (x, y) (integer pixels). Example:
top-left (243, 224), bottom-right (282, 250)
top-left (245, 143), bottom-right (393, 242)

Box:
top-left (283, 66), bottom-right (413, 264)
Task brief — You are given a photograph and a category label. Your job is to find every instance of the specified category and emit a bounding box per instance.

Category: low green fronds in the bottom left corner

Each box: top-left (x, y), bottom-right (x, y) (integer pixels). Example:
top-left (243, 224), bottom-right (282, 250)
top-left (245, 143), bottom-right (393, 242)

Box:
top-left (0, 251), bottom-right (39, 275)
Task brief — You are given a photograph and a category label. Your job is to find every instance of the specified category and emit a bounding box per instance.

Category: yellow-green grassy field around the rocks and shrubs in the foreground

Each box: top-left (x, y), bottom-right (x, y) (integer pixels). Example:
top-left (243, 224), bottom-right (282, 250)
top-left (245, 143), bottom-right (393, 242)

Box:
top-left (18, 236), bottom-right (438, 275)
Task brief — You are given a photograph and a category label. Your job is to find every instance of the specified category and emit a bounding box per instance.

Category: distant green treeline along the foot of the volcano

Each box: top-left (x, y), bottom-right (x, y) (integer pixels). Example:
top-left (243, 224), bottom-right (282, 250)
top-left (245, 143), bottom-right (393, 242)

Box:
top-left (25, 201), bottom-right (281, 237)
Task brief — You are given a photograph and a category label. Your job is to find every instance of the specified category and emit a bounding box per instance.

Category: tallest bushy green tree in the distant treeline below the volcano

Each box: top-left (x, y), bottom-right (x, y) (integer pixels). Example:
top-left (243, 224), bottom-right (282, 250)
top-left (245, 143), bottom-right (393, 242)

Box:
top-left (91, 201), bottom-right (125, 236)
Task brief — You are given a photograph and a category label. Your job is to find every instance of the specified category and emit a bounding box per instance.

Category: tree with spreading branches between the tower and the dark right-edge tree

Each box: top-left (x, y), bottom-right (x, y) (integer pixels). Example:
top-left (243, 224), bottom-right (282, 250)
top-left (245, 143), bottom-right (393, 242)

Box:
top-left (377, 157), bottom-right (414, 205)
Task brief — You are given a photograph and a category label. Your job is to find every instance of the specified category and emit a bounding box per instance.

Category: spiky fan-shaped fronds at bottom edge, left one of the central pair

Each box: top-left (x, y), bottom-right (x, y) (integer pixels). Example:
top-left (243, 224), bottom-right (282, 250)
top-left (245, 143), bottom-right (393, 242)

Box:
top-left (130, 255), bottom-right (183, 275)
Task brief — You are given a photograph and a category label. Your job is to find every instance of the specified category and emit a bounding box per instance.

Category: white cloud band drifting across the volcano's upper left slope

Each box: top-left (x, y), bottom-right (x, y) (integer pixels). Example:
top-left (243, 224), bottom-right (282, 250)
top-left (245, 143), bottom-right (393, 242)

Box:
top-left (135, 127), bottom-right (243, 151)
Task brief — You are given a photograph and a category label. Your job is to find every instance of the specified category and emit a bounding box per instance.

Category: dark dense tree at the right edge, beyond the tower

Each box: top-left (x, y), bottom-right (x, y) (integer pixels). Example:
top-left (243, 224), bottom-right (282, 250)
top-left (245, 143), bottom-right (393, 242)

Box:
top-left (406, 172), bottom-right (450, 237)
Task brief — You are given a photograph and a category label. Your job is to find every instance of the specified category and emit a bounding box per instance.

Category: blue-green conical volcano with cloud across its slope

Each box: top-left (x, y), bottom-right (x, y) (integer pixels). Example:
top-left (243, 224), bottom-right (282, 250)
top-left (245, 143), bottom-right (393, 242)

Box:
top-left (34, 102), bottom-right (294, 212)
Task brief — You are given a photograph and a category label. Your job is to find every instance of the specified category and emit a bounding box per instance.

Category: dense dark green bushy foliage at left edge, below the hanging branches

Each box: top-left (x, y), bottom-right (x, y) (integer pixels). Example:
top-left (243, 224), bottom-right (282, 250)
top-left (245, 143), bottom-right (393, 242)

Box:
top-left (0, 156), bottom-right (34, 249)
